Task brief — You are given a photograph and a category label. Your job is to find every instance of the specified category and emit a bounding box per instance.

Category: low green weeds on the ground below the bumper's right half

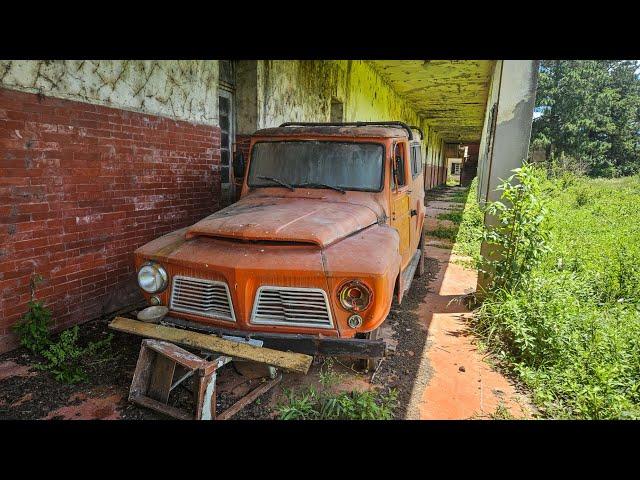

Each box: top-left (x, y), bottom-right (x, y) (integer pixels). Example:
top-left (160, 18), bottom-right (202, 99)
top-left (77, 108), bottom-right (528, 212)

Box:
top-left (277, 362), bottom-right (397, 420)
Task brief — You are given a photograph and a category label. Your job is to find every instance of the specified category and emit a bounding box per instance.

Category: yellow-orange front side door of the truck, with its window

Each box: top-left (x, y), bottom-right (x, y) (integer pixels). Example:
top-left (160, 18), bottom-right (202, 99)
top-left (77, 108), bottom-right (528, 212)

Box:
top-left (390, 143), bottom-right (413, 270)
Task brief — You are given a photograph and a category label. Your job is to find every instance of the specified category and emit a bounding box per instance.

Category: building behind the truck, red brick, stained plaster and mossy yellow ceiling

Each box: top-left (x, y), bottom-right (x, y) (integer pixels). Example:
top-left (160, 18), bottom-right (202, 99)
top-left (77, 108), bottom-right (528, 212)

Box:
top-left (0, 60), bottom-right (536, 352)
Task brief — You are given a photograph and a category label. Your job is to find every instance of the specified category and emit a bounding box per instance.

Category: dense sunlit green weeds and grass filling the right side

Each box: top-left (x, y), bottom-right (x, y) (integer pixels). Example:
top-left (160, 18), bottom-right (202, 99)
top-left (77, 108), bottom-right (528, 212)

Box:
top-left (462, 167), bottom-right (640, 419)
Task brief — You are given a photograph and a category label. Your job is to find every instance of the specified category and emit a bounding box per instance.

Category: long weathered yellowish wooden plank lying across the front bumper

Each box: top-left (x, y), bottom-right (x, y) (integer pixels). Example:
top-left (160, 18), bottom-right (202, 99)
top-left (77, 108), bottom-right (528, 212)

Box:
top-left (109, 317), bottom-right (313, 373)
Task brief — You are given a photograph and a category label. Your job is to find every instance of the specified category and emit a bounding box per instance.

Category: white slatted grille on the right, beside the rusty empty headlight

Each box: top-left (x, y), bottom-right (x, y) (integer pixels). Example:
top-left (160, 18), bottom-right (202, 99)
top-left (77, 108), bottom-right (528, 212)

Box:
top-left (251, 286), bottom-right (333, 328)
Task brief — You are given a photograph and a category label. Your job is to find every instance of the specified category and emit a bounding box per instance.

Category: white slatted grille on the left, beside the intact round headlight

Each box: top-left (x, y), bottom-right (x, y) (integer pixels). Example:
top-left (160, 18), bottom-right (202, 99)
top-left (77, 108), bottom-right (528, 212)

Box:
top-left (169, 276), bottom-right (236, 322)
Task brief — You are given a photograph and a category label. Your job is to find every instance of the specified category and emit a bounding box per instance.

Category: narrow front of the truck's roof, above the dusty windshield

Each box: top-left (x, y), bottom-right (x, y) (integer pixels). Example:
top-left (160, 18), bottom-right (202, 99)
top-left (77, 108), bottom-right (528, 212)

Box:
top-left (253, 124), bottom-right (418, 138)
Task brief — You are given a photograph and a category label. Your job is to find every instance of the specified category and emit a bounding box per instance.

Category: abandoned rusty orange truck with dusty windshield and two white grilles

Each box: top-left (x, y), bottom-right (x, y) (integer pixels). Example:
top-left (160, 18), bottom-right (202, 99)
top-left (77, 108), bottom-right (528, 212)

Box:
top-left (135, 122), bottom-right (425, 358)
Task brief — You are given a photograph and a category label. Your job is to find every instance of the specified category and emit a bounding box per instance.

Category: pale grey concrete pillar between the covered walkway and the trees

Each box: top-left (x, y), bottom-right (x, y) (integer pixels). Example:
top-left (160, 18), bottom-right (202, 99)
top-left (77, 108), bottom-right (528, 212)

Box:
top-left (478, 60), bottom-right (539, 292)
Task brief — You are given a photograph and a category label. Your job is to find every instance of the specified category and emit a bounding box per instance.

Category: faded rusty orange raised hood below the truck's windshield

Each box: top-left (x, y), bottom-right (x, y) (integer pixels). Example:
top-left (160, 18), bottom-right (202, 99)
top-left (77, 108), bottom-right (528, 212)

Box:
top-left (185, 197), bottom-right (378, 247)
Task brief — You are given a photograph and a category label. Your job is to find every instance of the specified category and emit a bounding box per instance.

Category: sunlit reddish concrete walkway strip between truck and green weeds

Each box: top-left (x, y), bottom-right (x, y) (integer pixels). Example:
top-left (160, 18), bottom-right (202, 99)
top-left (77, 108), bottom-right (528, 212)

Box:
top-left (412, 187), bottom-right (531, 420)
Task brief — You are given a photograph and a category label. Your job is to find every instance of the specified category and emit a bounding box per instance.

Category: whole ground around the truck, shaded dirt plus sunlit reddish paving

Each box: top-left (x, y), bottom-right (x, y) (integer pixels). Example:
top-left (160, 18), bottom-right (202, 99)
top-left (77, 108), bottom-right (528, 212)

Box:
top-left (0, 187), bottom-right (530, 420)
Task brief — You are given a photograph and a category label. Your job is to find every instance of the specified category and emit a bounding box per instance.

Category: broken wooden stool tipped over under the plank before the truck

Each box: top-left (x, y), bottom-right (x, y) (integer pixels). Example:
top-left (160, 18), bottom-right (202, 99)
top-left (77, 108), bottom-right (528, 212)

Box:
top-left (129, 339), bottom-right (282, 420)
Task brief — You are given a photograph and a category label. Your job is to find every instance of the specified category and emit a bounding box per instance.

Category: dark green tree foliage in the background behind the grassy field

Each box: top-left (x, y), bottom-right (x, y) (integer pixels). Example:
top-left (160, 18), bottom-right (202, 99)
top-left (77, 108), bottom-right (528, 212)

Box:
top-left (532, 60), bottom-right (640, 177)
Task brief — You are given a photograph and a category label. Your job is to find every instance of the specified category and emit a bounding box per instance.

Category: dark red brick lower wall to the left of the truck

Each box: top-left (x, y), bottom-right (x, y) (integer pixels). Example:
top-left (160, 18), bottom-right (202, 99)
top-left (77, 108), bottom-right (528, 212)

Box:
top-left (0, 89), bottom-right (220, 352)
